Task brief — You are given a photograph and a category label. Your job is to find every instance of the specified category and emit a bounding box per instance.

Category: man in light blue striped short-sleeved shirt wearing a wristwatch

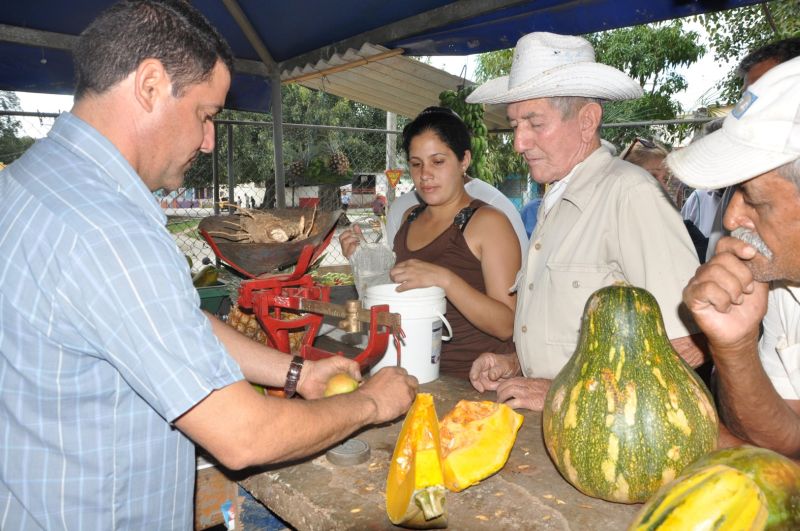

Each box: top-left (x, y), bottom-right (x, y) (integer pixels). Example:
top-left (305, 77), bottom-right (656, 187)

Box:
top-left (0, 0), bottom-right (416, 530)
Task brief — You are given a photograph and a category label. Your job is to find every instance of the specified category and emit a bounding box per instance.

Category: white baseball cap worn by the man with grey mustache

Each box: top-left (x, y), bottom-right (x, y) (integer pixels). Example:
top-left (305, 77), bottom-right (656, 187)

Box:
top-left (667, 57), bottom-right (800, 189)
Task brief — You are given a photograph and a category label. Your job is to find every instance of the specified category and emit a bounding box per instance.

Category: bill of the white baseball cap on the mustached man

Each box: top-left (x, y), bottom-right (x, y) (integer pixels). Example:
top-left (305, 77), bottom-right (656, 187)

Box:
top-left (667, 128), bottom-right (797, 190)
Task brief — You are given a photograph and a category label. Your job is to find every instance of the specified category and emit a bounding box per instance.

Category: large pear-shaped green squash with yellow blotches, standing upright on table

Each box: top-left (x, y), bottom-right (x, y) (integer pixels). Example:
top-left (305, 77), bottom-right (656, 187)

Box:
top-left (542, 284), bottom-right (718, 503)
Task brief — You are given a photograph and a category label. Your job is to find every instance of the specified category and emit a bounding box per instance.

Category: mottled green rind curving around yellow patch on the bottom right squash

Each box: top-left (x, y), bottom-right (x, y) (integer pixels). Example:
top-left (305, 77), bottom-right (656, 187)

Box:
top-left (683, 446), bottom-right (800, 531)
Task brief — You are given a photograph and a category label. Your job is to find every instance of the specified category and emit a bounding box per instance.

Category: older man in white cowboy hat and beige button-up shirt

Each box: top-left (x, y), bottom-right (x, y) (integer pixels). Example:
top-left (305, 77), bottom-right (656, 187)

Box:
top-left (467, 32), bottom-right (703, 410)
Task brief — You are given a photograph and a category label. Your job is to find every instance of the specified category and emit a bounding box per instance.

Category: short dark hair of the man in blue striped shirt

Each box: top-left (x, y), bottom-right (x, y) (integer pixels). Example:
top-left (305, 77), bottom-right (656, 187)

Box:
top-left (73, 0), bottom-right (233, 100)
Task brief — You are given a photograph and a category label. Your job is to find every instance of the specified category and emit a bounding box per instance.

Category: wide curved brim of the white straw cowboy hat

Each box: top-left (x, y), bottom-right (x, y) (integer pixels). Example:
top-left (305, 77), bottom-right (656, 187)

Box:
top-left (467, 62), bottom-right (643, 103)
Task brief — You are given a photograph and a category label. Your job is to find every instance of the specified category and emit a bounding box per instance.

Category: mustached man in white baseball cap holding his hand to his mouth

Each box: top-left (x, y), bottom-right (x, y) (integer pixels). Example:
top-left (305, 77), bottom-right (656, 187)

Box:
top-left (667, 58), bottom-right (800, 457)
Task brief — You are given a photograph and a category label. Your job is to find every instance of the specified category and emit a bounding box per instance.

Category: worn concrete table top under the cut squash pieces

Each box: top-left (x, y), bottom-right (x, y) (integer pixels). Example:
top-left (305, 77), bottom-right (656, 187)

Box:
top-left (240, 377), bottom-right (641, 531)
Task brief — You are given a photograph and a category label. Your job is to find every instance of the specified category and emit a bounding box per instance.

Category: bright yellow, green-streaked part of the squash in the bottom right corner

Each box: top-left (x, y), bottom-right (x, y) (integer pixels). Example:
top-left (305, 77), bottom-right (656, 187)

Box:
top-left (629, 465), bottom-right (769, 531)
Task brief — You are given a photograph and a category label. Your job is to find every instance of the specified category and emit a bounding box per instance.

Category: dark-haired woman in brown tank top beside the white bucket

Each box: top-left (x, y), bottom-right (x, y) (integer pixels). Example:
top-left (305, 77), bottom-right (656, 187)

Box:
top-left (390, 107), bottom-right (520, 378)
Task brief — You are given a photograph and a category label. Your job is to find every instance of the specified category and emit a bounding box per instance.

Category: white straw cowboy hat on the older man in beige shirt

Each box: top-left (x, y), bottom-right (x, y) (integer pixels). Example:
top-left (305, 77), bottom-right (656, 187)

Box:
top-left (467, 32), bottom-right (642, 103)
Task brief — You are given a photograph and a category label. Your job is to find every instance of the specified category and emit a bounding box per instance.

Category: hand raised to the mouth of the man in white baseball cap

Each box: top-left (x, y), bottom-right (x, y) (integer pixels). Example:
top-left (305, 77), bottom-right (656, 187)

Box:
top-left (683, 237), bottom-right (769, 349)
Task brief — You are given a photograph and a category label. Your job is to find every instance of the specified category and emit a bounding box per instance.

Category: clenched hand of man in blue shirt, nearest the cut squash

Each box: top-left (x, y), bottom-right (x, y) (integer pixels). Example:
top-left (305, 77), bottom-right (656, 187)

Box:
top-left (353, 367), bottom-right (419, 424)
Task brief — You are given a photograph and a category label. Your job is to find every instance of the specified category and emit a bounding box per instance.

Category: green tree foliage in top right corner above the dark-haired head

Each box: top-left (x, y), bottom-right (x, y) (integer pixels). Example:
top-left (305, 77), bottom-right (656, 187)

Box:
top-left (695, 0), bottom-right (800, 105)
